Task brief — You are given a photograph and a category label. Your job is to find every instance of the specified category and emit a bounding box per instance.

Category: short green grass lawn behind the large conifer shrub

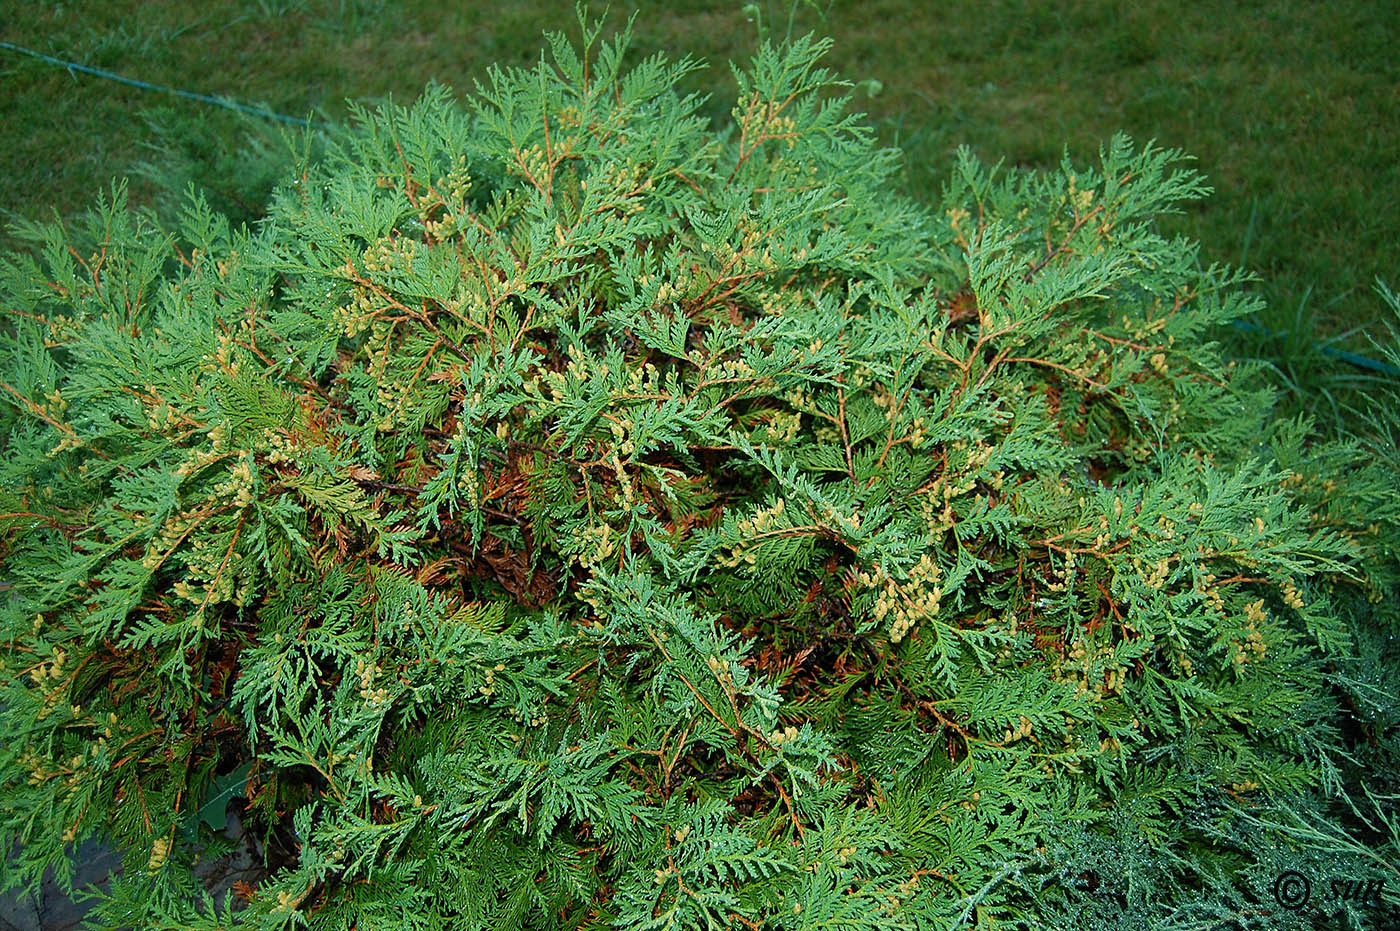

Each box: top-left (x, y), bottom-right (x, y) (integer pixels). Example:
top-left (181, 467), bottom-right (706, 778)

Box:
top-left (0, 0), bottom-right (1400, 406)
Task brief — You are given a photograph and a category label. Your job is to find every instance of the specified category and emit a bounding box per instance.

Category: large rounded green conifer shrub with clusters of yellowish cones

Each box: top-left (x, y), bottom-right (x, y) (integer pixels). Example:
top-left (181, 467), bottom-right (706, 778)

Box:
top-left (0, 16), bottom-right (1400, 930)
